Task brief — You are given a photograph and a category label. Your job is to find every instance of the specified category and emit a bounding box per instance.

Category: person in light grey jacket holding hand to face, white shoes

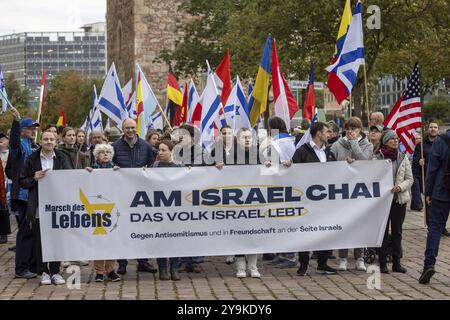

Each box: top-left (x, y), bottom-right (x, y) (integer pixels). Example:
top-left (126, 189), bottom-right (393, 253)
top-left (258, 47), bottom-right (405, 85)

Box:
top-left (330, 117), bottom-right (373, 271)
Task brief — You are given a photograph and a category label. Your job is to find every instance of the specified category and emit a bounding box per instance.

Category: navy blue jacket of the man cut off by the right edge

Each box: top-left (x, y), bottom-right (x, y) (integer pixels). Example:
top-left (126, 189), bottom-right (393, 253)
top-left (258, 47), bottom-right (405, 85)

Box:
top-left (425, 129), bottom-right (450, 202)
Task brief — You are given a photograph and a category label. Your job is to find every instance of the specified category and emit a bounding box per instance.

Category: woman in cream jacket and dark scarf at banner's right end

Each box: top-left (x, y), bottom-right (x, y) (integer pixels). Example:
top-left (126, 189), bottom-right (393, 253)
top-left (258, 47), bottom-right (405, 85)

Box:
top-left (376, 130), bottom-right (413, 273)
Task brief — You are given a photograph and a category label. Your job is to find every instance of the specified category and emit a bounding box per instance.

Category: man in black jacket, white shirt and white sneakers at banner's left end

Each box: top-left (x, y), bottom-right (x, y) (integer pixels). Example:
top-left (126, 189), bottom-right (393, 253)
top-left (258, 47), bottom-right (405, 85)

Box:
top-left (20, 132), bottom-right (68, 285)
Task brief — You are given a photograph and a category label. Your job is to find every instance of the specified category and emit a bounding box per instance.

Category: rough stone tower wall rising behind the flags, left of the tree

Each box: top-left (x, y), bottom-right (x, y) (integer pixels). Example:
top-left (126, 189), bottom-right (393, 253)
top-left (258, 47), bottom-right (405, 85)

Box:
top-left (107, 0), bottom-right (188, 101)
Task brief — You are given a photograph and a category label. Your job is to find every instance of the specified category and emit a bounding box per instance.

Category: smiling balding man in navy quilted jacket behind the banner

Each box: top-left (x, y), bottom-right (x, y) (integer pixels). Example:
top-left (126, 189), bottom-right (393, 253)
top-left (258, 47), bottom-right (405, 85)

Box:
top-left (112, 119), bottom-right (157, 274)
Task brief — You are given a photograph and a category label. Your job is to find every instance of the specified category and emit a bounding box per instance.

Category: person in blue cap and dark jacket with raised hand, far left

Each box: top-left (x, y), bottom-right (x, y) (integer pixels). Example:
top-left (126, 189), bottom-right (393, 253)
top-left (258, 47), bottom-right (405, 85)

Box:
top-left (5, 108), bottom-right (39, 279)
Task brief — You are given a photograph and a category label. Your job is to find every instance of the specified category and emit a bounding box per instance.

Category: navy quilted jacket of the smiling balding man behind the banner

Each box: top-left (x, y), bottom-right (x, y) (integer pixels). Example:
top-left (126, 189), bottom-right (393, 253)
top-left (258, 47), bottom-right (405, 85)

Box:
top-left (112, 137), bottom-right (154, 168)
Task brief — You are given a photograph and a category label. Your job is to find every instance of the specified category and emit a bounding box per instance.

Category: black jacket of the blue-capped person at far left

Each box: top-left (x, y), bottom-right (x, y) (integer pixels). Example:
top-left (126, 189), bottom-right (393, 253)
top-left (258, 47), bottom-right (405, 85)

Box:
top-left (5, 120), bottom-right (38, 200)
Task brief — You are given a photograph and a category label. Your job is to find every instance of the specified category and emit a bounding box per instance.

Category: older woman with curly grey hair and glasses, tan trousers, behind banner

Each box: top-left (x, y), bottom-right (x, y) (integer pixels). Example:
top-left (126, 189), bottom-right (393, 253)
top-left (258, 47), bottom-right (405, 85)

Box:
top-left (86, 144), bottom-right (120, 282)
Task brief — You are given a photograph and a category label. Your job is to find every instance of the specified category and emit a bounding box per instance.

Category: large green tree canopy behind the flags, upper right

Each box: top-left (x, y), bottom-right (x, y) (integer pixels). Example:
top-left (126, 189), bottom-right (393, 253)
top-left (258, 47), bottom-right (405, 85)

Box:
top-left (159, 0), bottom-right (450, 122)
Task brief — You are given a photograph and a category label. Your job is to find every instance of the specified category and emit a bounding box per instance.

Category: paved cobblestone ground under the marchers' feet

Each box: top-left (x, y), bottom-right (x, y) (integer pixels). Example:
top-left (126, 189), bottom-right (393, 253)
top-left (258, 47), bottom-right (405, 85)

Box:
top-left (0, 211), bottom-right (450, 300)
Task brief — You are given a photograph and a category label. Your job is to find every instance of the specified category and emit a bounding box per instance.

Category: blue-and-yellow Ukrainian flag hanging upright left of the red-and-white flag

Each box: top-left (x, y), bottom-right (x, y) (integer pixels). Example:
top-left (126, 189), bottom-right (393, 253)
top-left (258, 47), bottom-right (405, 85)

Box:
top-left (248, 36), bottom-right (270, 128)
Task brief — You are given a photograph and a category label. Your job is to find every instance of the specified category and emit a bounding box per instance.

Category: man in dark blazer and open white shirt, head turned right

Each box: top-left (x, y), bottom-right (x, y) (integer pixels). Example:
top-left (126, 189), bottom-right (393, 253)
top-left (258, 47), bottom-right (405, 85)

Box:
top-left (292, 122), bottom-right (336, 276)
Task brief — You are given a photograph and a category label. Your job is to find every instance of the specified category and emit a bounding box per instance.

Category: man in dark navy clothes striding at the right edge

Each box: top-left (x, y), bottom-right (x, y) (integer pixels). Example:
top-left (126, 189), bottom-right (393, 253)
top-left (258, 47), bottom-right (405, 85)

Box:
top-left (419, 129), bottom-right (450, 284)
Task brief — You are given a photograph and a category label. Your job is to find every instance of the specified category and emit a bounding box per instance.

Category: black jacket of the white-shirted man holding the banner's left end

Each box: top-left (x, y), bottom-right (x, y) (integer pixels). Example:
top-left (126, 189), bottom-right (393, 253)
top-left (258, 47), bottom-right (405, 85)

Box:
top-left (20, 148), bottom-right (67, 221)
